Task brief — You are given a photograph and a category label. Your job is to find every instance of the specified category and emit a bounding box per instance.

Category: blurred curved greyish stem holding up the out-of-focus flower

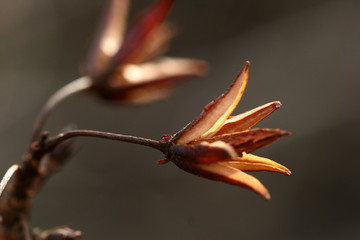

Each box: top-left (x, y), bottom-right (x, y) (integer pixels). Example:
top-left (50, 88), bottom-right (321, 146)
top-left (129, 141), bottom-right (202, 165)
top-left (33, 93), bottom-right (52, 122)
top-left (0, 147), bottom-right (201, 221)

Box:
top-left (31, 76), bottom-right (92, 142)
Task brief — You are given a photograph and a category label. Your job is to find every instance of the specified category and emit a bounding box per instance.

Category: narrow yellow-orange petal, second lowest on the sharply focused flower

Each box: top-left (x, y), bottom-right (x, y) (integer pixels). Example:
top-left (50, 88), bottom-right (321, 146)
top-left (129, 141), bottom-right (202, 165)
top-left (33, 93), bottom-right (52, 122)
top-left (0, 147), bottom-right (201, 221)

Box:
top-left (227, 153), bottom-right (291, 176)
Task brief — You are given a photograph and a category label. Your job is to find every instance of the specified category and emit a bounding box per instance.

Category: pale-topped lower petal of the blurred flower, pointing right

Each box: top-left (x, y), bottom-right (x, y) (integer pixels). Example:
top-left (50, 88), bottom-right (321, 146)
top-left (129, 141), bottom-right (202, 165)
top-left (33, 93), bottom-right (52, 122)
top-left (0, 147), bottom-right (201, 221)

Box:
top-left (104, 58), bottom-right (207, 104)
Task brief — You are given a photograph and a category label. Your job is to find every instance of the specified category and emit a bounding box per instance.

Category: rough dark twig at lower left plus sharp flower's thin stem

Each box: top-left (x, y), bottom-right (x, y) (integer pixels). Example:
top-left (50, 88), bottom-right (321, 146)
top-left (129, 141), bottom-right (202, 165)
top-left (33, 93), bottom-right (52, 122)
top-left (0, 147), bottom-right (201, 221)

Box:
top-left (0, 130), bottom-right (169, 240)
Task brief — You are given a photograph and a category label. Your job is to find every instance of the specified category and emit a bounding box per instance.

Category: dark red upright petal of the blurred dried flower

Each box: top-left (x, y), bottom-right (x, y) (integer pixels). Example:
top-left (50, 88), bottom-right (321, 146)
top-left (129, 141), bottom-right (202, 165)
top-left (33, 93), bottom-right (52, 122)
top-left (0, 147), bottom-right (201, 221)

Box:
top-left (113, 0), bottom-right (173, 66)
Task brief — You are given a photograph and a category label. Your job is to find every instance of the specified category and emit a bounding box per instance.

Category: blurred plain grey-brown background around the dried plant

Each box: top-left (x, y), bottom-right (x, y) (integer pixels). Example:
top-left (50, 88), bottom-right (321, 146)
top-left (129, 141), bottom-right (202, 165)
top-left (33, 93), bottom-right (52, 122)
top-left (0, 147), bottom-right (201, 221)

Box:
top-left (0, 0), bottom-right (360, 240)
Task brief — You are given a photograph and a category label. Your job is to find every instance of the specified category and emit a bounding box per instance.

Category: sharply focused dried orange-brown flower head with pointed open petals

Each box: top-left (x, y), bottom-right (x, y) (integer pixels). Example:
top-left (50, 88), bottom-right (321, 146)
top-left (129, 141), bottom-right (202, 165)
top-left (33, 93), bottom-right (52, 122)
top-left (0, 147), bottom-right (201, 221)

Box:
top-left (160, 62), bottom-right (291, 200)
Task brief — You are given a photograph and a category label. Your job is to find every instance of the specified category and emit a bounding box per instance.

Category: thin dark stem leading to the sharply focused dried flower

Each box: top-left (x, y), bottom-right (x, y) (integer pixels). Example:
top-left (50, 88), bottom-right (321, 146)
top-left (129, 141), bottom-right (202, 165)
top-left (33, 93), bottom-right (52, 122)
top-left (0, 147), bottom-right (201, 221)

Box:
top-left (46, 130), bottom-right (167, 153)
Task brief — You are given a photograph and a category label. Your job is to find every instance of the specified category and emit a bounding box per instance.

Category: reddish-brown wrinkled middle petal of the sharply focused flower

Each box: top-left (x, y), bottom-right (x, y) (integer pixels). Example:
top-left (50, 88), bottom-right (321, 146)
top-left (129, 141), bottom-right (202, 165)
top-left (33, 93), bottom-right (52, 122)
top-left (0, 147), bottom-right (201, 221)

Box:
top-left (205, 128), bottom-right (290, 155)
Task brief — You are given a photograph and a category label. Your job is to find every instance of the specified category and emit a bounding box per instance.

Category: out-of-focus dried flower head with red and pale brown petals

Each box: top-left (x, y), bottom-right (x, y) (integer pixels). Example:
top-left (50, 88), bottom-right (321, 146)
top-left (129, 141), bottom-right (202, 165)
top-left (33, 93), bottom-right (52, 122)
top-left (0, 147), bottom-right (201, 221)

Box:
top-left (85, 0), bottom-right (206, 103)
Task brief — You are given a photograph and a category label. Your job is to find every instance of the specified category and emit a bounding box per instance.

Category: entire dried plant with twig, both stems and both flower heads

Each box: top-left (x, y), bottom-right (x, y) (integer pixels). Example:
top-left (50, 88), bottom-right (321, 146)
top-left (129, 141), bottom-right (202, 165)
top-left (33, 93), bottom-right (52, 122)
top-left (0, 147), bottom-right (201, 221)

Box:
top-left (0, 0), bottom-right (291, 240)
